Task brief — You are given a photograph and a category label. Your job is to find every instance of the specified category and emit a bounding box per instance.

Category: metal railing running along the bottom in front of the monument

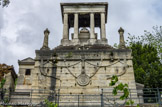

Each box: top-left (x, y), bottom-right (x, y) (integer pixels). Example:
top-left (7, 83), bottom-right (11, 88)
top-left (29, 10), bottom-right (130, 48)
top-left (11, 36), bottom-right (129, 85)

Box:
top-left (0, 88), bottom-right (162, 107)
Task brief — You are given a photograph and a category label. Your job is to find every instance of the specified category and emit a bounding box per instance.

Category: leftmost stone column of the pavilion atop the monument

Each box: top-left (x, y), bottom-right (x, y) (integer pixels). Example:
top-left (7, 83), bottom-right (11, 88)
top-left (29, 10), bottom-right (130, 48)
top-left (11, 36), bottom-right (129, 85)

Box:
top-left (63, 13), bottom-right (69, 40)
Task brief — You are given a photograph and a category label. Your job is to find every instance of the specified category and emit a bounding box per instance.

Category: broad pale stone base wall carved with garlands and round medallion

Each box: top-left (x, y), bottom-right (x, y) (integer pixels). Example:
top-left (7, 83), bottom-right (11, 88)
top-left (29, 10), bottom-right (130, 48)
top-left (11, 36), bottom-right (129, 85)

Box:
top-left (28, 49), bottom-right (138, 103)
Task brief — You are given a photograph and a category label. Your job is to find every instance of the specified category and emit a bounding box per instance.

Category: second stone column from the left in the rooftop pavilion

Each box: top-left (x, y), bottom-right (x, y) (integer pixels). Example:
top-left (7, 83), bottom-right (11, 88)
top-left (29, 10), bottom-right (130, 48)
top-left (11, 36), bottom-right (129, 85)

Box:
top-left (74, 13), bottom-right (79, 39)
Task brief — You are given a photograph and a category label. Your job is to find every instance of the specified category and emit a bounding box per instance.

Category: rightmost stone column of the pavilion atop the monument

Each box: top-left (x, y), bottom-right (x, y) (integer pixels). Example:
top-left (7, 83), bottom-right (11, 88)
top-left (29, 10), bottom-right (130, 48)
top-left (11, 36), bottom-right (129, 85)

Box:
top-left (101, 13), bottom-right (107, 40)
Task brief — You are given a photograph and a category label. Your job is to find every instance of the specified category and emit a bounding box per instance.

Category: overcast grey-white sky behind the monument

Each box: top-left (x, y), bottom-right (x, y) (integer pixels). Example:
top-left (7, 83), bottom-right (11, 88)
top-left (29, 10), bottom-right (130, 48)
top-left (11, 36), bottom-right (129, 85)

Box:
top-left (0, 0), bottom-right (162, 72)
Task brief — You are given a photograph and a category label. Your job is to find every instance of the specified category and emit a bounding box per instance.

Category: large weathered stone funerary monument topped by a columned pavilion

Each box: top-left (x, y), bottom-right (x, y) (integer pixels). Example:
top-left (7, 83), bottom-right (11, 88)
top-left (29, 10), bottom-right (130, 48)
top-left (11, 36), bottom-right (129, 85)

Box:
top-left (15, 2), bottom-right (136, 106)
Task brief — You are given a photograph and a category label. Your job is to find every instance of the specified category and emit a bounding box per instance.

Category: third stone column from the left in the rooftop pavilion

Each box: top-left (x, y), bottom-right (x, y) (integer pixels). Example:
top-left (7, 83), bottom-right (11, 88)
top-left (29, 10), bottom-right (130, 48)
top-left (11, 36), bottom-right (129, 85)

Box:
top-left (90, 13), bottom-right (95, 39)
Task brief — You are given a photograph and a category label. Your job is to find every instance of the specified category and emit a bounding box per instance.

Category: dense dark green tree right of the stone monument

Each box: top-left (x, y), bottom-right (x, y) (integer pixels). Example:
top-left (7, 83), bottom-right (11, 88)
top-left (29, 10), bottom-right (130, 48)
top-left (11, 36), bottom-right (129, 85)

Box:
top-left (131, 42), bottom-right (162, 88)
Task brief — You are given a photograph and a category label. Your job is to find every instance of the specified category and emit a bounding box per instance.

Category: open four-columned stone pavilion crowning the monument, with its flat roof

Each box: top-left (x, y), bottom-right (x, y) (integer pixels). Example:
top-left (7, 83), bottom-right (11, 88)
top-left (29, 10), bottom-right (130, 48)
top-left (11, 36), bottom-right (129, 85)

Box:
top-left (61, 3), bottom-right (108, 46)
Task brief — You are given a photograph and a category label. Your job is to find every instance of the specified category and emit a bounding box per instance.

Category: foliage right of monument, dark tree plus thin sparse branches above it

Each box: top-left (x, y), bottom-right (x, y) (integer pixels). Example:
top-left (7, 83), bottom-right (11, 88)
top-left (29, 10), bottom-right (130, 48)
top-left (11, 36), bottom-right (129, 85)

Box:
top-left (127, 27), bottom-right (162, 88)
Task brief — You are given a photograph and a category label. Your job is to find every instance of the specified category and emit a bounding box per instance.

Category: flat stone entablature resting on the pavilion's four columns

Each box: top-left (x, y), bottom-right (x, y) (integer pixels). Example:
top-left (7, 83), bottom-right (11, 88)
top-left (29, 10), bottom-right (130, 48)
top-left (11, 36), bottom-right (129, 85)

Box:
top-left (60, 2), bottom-right (108, 23)
